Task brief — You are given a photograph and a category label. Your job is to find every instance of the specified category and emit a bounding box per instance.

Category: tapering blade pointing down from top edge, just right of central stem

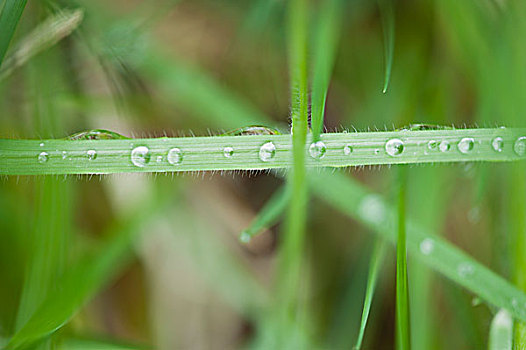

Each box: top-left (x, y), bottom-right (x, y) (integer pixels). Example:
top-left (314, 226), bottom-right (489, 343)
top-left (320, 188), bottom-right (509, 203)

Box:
top-left (311, 0), bottom-right (344, 142)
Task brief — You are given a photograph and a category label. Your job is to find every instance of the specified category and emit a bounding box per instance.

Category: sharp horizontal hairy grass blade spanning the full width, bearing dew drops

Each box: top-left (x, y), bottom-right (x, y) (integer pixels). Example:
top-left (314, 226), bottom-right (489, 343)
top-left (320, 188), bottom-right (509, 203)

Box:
top-left (0, 128), bottom-right (526, 175)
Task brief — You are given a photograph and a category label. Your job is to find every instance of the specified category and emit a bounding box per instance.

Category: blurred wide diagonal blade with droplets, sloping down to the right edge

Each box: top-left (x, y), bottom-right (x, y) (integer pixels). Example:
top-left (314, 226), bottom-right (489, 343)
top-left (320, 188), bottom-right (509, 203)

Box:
top-left (309, 171), bottom-right (526, 321)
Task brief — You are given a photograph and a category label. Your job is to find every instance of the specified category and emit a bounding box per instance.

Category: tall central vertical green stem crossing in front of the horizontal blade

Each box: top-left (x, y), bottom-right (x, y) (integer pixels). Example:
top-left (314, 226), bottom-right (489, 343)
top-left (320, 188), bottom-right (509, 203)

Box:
top-left (276, 0), bottom-right (308, 347)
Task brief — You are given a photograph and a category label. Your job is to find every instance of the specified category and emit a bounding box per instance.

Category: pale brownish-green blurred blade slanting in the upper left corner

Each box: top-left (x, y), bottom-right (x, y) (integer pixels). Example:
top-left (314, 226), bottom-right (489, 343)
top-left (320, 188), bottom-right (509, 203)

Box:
top-left (0, 9), bottom-right (84, 81)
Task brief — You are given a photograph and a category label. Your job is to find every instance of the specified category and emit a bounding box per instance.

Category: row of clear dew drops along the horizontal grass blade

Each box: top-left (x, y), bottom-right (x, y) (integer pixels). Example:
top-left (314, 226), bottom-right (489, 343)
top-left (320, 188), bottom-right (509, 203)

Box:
top-left (37, 136), bottom-right (526, 167)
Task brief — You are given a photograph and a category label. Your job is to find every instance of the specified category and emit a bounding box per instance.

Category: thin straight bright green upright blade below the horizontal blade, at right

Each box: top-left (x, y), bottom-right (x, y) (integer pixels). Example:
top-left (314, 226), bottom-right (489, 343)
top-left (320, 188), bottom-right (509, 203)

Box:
top-left (396, 165), bottom-right (411, 350)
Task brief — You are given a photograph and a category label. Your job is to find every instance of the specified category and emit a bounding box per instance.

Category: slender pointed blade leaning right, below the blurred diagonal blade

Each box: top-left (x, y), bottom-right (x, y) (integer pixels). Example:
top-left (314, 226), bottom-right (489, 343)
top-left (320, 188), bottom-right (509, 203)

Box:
top-left (354, 238), bottom-right (386, 350)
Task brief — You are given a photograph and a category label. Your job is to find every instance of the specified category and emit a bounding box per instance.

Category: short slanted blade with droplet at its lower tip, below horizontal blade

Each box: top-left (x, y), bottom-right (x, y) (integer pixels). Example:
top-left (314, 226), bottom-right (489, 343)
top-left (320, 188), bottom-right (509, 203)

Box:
top-left (239, 185), bottom-right (291, 243)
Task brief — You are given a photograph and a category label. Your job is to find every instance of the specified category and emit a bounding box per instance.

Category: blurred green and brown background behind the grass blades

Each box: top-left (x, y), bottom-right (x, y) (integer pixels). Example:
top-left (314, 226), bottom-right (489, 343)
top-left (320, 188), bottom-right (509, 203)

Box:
top-left (0, 0), bottom-right (526, 349)
